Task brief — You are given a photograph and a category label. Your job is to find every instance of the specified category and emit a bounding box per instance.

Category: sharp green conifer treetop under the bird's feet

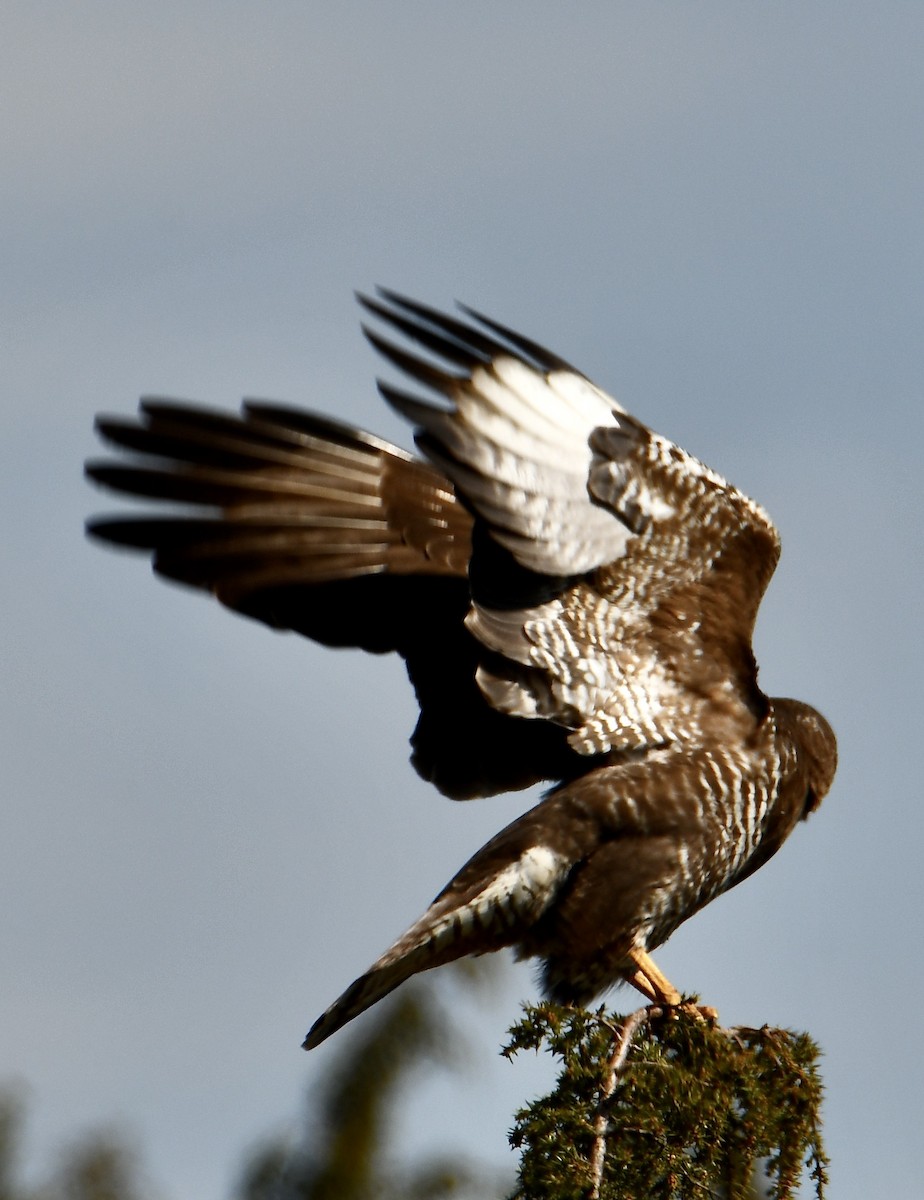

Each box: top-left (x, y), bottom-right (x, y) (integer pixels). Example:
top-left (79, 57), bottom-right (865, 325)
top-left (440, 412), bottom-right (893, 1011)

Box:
top-left (504, 1004), bottom-right (828, 1200)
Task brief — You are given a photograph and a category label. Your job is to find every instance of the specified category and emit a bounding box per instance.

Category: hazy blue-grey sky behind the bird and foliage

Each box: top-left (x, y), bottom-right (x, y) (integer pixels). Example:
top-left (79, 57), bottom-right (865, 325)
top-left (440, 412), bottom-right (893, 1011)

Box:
top-left (0, 0), bottom-right (924, 1200)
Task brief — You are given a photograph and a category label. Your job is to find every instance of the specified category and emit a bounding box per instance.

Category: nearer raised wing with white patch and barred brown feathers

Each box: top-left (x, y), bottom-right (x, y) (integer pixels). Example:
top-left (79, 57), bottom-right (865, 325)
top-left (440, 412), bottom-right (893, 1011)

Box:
top-left (360, 292), bottom-right (779, 755)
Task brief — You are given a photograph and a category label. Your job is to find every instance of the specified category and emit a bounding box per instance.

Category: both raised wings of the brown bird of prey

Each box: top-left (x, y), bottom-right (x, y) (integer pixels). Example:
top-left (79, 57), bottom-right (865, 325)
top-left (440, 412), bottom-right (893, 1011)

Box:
top-left (88, 285), bottom-right (779, 798)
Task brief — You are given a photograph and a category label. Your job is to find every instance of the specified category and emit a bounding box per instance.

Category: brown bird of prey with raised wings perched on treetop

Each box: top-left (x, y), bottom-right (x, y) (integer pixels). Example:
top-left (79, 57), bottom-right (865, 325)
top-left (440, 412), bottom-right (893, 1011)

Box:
top-left (88, 290), bottom-right (836, 1048)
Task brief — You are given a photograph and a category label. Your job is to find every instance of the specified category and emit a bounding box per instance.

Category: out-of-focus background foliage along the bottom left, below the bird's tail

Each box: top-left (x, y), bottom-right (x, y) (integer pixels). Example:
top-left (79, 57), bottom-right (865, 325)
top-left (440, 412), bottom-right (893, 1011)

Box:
top-left (0, 964), bottom-right (510, 1200)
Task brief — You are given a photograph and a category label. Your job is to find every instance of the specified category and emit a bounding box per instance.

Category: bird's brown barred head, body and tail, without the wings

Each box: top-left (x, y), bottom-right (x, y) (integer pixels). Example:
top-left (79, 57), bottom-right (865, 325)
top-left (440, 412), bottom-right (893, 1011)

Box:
top-left (305, 700), bottom-right (834, 1049)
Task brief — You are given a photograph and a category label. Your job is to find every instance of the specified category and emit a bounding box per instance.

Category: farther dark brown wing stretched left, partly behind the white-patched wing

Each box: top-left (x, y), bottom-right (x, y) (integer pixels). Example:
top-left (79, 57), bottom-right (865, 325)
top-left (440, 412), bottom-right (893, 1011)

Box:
top-left (86, 400), bottom-right (575, 799)
